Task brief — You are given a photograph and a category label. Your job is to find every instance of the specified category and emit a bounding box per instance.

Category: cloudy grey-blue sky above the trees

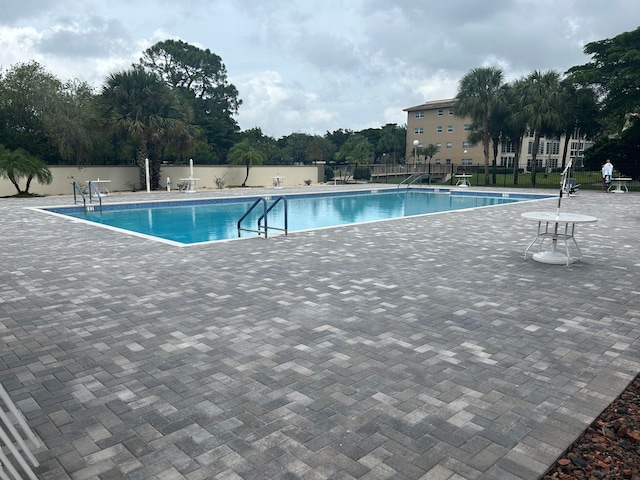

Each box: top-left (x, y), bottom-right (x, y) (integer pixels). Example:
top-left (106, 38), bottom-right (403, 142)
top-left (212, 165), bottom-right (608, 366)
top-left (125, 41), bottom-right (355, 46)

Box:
top-left (0, 0), bottom-right (640, 138)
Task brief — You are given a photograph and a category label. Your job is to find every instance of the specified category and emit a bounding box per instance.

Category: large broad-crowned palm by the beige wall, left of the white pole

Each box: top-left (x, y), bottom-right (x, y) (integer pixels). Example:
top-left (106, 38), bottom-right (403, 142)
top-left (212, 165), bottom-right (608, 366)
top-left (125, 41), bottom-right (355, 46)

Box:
top-left (100, 66), bottom-right (194, 190)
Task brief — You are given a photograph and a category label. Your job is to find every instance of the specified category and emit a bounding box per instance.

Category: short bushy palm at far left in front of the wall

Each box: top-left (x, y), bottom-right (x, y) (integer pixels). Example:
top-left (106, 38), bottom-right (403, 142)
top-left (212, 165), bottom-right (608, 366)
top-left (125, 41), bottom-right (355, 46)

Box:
top-left (0, 145), bottom-right (53, 195)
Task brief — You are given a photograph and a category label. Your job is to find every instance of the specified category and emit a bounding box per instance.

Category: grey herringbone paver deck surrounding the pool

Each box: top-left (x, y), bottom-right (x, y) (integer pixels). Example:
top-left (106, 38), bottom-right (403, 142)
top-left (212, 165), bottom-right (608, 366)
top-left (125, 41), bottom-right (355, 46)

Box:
top-left (0, 185), bottom-right (640, 480)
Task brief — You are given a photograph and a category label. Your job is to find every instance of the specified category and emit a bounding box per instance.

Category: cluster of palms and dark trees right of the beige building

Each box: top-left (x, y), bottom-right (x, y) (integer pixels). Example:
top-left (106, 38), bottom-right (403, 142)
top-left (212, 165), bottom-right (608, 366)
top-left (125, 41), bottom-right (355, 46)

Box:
top-left (455, 24), bottom-right (640, 186)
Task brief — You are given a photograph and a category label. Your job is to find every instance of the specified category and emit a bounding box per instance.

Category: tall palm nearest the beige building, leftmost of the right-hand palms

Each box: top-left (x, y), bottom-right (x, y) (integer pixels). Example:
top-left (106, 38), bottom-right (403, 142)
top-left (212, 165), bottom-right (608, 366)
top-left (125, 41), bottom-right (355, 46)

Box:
top-left (455, 67), bottom-right (504, 185)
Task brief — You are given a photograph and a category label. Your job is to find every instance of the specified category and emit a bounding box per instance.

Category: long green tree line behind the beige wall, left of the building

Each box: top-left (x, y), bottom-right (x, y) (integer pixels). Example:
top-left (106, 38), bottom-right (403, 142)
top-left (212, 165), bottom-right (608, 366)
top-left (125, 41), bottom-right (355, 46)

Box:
top-left (0, 40), bottom-right (406, 193)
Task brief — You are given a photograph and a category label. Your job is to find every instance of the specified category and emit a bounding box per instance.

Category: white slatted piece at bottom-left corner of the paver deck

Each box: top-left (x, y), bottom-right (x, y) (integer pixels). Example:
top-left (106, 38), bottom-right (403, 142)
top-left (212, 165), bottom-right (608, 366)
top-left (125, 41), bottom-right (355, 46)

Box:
top-left (0, 384), bottom-right (42, 480)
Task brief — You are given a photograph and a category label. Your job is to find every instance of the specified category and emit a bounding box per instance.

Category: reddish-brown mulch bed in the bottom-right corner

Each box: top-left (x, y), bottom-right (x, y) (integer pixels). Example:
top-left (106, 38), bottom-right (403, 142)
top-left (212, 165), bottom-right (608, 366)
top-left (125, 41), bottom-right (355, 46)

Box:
top-left (542, 375), bottom-right (640, 480)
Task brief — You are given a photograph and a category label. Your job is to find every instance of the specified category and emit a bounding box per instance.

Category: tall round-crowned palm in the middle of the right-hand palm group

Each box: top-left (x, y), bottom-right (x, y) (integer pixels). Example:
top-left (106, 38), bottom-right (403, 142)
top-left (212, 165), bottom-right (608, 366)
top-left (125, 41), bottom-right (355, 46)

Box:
top-left (520, 70), bottom-right (566, 187)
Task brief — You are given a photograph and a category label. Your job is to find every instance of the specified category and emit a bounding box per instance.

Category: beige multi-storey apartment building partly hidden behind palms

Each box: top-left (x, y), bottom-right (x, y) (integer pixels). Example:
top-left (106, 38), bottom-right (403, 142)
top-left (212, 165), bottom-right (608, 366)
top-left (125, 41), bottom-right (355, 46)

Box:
top-left (403, 98), bottom-right (593, 170)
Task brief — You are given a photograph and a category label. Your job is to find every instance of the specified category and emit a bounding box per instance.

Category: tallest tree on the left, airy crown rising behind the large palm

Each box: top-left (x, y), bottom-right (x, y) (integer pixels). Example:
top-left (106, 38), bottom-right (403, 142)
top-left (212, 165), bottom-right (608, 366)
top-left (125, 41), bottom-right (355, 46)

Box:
top-left (140, 40), bottom-right (242, 163)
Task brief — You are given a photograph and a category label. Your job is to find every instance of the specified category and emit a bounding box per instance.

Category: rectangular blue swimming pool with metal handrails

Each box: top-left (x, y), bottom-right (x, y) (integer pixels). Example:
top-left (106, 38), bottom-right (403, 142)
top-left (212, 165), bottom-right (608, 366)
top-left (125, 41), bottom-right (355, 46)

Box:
top-left (41, 188), bottom-right (548, 246)
